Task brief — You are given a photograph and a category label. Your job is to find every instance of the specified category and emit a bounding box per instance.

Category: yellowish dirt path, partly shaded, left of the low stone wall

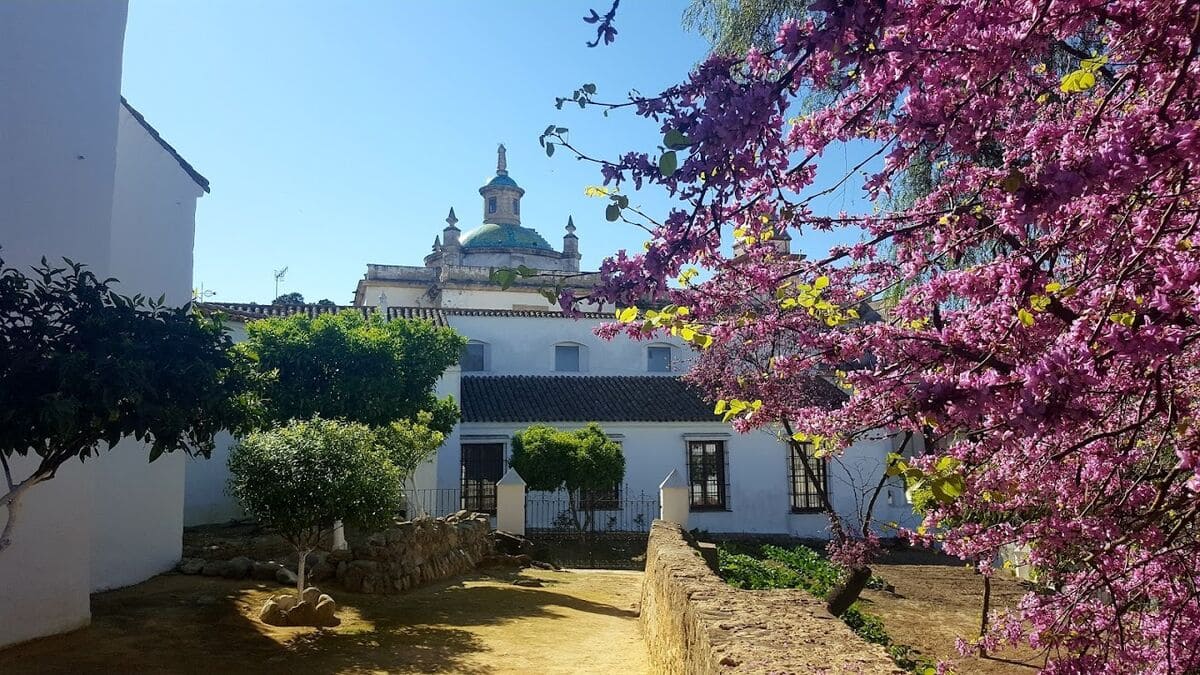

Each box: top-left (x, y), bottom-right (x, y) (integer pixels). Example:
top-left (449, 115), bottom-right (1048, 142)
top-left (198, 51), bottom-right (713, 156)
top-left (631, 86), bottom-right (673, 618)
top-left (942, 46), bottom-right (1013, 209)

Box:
top-left (0, 571), bottom-right (648, 675)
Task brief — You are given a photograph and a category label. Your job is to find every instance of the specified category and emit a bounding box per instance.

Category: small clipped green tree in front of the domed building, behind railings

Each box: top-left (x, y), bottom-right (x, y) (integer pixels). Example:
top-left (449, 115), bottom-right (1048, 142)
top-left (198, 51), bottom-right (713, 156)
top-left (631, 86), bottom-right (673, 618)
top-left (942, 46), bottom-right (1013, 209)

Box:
top-left (511, 423), bottom-right (625, 531)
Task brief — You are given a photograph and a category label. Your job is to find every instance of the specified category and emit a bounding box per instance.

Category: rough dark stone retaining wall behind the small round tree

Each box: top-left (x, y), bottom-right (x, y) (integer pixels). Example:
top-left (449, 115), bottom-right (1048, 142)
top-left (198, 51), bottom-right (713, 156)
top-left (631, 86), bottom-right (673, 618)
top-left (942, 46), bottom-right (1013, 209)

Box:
top-left (326, 512), bottom-right (492, 593)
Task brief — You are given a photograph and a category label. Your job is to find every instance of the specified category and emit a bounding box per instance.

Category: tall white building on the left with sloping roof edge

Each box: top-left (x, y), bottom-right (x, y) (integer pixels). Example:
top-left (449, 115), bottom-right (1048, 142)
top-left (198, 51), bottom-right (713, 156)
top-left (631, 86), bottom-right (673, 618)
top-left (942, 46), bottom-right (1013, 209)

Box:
top-left (0, 0), bottom-right (208, 646)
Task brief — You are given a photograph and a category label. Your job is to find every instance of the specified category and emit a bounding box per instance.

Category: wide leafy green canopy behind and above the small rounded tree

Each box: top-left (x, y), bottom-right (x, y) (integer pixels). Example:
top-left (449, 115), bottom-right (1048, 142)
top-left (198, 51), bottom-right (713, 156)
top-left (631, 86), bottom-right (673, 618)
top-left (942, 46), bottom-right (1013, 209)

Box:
top-left (235, 310), bottom-right (466, 434)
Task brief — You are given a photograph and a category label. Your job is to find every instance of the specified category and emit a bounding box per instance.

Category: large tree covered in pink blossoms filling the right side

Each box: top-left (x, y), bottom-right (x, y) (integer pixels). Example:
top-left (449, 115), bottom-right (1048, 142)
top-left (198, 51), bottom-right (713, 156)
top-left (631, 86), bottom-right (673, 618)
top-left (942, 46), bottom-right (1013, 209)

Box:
top-left (556, 0), bottom-right (1200, 673)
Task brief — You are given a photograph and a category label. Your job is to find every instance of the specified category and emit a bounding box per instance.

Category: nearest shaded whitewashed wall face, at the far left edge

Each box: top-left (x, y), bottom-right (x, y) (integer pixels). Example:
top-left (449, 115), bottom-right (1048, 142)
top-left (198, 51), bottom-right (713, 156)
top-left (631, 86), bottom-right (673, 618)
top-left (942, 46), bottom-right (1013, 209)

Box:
top-left (0, 0), bottom-right (126, 646)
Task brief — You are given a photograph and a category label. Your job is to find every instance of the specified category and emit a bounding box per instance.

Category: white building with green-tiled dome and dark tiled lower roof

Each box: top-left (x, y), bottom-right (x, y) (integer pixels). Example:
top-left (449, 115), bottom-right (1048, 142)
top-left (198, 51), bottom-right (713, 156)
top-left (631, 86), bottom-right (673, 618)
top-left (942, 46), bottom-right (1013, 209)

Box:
top-left (196, 147), bottom-right (911, 537)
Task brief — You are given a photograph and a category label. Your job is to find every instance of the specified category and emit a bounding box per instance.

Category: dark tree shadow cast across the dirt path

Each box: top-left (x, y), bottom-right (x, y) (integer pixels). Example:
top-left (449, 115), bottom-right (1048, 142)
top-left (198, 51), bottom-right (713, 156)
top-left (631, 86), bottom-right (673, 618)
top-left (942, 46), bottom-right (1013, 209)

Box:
top-left (0, 573), bottom-right (637, 675)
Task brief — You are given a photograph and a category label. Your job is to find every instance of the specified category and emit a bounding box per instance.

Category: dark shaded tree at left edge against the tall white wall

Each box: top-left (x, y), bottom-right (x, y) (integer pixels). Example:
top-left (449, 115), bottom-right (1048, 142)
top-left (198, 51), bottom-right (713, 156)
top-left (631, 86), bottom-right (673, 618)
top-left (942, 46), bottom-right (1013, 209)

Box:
top-left (0, 258), bottom-right (256, 551)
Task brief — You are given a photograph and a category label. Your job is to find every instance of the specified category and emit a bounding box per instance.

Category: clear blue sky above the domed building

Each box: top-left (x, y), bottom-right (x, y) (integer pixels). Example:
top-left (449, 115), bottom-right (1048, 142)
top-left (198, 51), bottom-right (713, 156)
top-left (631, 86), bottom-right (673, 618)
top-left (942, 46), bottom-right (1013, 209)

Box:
top-left (122, 0), bottom-right (873, 303)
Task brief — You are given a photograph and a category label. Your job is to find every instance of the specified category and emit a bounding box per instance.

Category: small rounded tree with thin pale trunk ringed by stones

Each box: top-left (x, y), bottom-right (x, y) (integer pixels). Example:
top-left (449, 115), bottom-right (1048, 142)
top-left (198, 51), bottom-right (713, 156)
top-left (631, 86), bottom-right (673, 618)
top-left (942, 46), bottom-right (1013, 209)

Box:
top-left (229, 417), bottom-right (402, 593)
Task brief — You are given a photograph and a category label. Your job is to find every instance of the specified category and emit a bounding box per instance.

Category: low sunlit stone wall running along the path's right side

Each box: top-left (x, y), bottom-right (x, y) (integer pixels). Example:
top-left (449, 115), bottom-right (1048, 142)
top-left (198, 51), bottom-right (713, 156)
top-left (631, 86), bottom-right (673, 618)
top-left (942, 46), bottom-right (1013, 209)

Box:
top-left (641, 520), bottom-right (902, 675)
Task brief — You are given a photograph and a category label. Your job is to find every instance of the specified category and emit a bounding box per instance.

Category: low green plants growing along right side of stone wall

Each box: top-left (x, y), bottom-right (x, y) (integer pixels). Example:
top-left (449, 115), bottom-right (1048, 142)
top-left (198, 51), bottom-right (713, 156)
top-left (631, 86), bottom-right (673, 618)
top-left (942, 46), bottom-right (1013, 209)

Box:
top-left (718, 542), bottom-right (937, 675)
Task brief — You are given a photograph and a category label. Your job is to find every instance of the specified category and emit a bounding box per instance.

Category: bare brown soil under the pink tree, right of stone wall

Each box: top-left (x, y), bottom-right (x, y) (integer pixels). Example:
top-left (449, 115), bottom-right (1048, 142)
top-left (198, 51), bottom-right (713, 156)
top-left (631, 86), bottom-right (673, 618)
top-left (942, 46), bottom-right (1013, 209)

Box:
top-left (862, 550), bottom-right (1043, 675)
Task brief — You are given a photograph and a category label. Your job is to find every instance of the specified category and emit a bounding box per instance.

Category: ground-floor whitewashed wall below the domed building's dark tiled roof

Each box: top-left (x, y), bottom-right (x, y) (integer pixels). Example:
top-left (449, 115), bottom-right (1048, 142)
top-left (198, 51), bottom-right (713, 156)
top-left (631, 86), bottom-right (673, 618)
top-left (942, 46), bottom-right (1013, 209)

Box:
top-left (453, 422), bottom-right (912, 538)
